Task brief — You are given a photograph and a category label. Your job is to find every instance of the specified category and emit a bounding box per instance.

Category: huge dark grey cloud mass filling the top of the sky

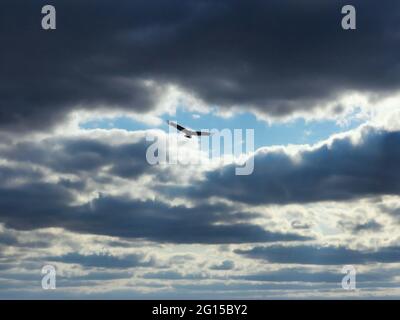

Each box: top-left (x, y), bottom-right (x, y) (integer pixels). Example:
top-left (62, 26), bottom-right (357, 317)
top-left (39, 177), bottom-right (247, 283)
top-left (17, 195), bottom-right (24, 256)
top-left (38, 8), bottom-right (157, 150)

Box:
top-left (0, 0), bottom-right (400, 130)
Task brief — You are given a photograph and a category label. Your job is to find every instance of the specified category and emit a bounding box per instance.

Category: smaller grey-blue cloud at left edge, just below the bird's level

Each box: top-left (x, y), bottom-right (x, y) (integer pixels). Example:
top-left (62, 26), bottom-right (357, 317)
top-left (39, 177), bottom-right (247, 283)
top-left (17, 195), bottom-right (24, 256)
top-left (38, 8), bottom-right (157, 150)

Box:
top-left (0, 137), bottom-right (153, 179)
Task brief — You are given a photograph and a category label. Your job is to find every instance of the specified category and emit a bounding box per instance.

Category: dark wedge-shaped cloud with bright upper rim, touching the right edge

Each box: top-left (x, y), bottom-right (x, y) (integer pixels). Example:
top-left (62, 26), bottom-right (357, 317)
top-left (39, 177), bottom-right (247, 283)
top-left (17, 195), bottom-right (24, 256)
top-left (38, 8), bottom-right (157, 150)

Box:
top-left (183, 128), bottom-right (400, 204)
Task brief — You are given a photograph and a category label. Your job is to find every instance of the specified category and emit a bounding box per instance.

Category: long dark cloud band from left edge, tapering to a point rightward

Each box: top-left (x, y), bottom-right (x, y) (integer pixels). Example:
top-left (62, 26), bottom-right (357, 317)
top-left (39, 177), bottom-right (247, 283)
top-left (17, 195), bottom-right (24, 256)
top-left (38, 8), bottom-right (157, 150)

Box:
top-left (0, 183), bottom-right (309, 244)
